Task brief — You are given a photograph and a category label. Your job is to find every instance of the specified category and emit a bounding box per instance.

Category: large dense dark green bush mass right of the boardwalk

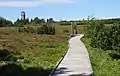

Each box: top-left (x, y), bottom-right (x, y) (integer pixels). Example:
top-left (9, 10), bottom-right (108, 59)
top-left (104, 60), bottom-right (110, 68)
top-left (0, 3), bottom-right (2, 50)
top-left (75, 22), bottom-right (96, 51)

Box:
top-left (85, 17), bottom-right (120, 50)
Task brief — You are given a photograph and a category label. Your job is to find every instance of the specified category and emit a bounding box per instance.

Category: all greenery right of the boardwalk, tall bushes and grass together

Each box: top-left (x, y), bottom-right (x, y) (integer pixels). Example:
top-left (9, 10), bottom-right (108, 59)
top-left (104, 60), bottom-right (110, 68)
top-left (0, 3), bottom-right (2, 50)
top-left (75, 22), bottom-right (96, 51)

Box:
top-left (82, 15), bottom-right (120, 76)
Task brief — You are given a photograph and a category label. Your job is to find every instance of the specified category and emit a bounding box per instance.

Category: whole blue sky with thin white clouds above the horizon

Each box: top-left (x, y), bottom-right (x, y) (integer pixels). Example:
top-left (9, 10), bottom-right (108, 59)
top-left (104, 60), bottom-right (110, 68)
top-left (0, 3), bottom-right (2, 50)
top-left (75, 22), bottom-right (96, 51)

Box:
top-left (0, 0), bottom-right (120, 21)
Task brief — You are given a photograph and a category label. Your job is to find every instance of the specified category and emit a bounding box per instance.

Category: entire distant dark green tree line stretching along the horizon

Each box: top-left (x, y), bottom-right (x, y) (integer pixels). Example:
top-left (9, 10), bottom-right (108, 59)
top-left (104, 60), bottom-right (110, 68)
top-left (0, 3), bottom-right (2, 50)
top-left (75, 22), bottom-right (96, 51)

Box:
top-left (0, 17), bottom-right (120, 27)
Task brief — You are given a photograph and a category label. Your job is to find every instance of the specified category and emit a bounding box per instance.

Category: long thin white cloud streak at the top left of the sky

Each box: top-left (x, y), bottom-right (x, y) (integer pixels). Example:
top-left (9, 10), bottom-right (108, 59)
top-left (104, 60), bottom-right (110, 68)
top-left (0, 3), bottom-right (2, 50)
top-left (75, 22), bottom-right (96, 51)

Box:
top-left (0, 0), bottom-right (75, 7)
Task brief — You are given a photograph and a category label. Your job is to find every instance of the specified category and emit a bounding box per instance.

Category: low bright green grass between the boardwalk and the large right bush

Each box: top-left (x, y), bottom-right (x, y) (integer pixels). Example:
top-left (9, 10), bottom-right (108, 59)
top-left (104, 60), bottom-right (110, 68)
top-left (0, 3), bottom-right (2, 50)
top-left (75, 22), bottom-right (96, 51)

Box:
top-left (82, 37), bottom-right (120, 76)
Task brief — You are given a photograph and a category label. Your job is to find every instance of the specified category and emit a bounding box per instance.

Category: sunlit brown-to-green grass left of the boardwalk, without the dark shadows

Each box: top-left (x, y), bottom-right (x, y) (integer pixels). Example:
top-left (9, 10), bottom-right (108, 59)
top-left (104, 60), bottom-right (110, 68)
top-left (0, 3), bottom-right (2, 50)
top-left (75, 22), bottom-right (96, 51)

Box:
top-left (0, 27), bottom-right (69, 76)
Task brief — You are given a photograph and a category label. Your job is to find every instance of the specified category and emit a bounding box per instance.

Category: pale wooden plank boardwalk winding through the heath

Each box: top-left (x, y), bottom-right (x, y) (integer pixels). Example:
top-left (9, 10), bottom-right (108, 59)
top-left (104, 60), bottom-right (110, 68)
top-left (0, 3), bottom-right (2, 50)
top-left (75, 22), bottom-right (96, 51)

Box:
top-left (52, 34), bottom-right (93, 76)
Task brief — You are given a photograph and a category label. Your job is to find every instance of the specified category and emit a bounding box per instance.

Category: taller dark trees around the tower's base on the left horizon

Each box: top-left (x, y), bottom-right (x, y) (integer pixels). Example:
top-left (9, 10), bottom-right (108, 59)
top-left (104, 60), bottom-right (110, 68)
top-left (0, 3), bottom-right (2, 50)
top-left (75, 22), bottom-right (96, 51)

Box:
top-left (0, 17), bottom-right (54, 27)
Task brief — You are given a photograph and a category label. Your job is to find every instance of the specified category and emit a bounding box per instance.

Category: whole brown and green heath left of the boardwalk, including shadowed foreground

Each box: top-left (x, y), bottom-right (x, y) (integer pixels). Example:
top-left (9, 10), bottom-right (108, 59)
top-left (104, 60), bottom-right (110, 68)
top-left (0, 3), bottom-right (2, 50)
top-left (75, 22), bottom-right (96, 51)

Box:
top-left (0, 27), bottom-right (69, 76)
